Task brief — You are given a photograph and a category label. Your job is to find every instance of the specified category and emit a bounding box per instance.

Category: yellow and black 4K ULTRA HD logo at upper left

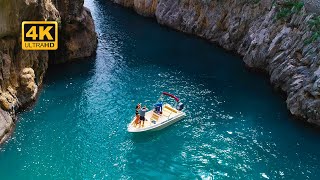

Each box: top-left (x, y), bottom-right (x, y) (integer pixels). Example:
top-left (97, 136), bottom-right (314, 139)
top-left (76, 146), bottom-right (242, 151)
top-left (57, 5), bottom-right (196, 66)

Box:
top-left (22, 21), bottom-right (58, 50)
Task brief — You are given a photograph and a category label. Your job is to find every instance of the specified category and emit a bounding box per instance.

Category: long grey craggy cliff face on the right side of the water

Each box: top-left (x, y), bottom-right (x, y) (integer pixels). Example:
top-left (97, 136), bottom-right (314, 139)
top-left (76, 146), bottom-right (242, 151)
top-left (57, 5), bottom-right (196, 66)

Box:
top-left (113, 0), bottom-right (320, 125)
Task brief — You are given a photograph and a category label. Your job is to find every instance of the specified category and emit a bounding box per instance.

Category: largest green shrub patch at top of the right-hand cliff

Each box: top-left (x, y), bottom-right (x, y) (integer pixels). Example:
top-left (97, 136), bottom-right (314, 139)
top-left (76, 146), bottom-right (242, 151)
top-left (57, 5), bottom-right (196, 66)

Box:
top-left (276, 0), bottom-right (304, 20)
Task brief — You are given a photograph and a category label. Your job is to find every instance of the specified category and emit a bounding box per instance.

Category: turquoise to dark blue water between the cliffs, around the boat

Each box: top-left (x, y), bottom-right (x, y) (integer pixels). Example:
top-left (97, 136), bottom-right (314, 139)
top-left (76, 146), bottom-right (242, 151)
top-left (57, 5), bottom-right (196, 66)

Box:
top-left (0, 0), bottom-right (320, 179)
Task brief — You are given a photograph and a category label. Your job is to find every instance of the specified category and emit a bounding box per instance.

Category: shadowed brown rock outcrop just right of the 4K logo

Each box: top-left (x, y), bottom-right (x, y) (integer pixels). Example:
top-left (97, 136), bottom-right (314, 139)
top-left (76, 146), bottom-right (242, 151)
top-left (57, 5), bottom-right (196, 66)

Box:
top-left (50, 0), bottom-right (97, 63)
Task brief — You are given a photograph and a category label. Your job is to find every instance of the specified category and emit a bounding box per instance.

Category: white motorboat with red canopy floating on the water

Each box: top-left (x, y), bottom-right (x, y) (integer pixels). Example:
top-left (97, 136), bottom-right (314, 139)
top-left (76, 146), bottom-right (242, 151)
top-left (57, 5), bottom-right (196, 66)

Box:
top-left (128, 92), bottom-right (186, 133)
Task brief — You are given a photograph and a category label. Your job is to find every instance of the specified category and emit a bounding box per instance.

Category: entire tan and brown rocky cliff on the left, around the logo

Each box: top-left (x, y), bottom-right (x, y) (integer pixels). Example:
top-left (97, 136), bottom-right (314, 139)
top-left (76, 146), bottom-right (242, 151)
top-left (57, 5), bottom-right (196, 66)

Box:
top-left (0, 0), bottom-right (97, 143)
